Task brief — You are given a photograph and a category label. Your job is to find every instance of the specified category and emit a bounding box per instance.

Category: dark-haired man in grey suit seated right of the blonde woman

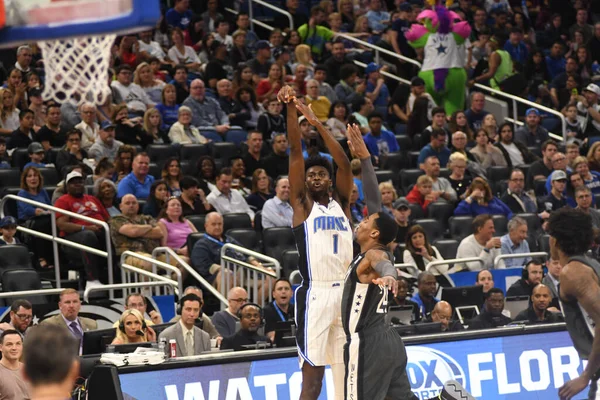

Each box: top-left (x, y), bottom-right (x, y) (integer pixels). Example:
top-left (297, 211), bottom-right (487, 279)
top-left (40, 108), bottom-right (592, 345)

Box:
top-left (158, 294), bottom-right (210, 357)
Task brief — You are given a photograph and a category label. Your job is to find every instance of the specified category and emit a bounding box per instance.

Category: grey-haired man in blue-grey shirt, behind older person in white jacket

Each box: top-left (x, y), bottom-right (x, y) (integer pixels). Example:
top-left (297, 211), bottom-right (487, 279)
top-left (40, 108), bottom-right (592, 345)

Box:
top-left (183, 79), bottom-right (229, 135)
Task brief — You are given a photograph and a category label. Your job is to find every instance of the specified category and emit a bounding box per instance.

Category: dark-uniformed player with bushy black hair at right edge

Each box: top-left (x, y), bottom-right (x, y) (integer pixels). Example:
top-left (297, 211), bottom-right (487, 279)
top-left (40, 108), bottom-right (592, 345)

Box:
top-left (548, 208), bottom-right (600, 400)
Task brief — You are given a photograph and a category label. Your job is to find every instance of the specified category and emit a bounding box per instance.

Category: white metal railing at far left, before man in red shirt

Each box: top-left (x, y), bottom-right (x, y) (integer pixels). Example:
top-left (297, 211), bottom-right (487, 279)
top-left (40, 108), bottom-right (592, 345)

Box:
top-left (0, 194), bottom-right (114, 299)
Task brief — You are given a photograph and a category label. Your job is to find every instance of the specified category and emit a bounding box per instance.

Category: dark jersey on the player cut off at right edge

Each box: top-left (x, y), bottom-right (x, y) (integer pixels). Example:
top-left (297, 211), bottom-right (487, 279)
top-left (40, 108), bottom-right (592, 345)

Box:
top-left (558, 256), bottom-right (600, 359)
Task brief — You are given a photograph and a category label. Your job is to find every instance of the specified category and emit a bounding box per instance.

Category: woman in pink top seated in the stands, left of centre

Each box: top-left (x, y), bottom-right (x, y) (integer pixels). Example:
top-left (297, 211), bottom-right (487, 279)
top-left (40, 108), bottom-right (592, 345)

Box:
top-left (158, 197), bottom-right (198, 264)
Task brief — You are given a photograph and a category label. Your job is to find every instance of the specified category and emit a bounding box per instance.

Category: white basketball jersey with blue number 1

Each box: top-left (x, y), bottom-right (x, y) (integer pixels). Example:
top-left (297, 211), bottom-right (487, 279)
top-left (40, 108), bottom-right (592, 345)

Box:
top-left (294, 199), bottom-right (353, 282)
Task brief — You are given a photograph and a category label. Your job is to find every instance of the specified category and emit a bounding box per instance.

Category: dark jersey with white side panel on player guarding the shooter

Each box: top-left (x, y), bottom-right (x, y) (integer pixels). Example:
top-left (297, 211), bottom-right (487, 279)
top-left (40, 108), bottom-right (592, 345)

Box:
top-left (342, 253), bottom-right (388, 336)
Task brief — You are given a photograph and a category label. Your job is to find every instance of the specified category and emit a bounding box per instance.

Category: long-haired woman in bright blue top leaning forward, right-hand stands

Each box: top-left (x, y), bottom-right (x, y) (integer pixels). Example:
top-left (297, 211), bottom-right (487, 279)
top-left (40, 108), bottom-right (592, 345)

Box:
top-left (454, 177), bottom-right (512, 220)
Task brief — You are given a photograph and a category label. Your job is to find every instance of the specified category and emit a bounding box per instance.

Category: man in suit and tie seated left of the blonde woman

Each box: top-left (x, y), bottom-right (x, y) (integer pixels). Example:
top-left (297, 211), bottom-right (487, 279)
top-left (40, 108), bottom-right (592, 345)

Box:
top-left (40, 289), bottom-right (98, 354)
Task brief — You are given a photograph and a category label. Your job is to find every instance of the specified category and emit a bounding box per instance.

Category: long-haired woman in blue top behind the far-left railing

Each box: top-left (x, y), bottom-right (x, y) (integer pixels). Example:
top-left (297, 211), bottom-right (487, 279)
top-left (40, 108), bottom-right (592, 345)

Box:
top-left (17, 167), bottom-right (54, 268)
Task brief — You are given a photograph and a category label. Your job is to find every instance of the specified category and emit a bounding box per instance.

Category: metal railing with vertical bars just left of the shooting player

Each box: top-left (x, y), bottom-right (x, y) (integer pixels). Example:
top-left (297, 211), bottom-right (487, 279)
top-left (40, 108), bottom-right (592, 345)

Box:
top-left (221, 243), bottom-right (281, 306)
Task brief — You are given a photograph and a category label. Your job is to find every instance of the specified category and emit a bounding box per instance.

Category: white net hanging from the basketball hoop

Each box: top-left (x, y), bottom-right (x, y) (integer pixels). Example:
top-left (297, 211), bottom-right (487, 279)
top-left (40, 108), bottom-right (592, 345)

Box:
top-left (38, 34), bottom-right (116, 104)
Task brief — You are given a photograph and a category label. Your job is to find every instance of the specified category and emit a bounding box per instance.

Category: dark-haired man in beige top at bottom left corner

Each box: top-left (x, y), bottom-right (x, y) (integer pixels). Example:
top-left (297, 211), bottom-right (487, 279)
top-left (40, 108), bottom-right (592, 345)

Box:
top-left (0, 329), bottom-right (30, 400)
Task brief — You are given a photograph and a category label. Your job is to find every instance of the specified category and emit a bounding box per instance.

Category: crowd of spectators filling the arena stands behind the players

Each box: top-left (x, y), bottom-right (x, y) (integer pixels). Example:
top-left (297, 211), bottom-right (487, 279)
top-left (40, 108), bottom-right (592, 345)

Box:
top-left (0, 0), bottom-right (600, 390)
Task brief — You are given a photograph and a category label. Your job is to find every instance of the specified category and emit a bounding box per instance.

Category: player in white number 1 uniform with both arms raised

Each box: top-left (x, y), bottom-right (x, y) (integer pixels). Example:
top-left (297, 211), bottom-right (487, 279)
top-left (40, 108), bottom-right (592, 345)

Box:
top-left (278, 86), bottom-right (352, 400)
